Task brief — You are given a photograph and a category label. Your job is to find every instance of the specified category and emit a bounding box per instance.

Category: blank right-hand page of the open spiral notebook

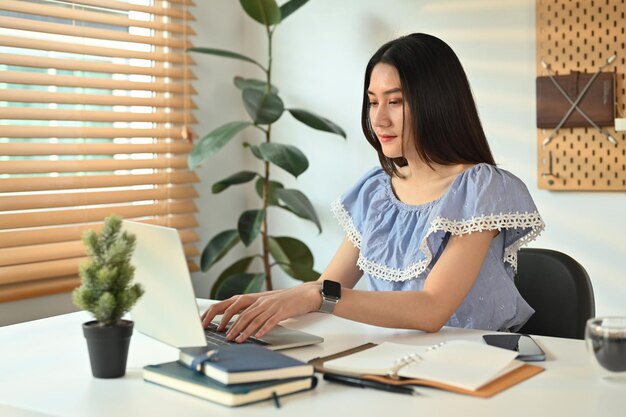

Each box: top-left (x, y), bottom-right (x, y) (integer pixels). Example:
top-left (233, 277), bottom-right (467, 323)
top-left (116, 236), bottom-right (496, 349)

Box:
top-left (398, 340), bottom-right (519, 390)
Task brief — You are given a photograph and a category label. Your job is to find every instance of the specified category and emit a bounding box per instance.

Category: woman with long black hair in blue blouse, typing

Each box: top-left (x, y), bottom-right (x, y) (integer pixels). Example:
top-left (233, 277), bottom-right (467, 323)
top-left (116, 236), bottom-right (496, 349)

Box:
top-left (203, 34), bottom-right (544, 342)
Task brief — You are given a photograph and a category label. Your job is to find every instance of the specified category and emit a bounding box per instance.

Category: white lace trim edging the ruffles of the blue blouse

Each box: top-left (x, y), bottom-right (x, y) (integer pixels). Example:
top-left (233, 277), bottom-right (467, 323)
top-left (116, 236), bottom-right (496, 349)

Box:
top-left (331, 198), bottom-right (545, 281)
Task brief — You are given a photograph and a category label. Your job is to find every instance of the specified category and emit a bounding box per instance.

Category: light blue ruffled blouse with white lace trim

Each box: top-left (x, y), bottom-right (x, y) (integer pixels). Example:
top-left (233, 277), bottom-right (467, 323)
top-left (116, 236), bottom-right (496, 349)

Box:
top-left (332, 164), bottom-right (544, 331)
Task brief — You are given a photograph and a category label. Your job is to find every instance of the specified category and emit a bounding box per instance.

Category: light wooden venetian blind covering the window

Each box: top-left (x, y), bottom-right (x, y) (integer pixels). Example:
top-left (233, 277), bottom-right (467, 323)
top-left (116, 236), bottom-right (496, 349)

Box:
top-left (0, 0), bottom-right (198, 301)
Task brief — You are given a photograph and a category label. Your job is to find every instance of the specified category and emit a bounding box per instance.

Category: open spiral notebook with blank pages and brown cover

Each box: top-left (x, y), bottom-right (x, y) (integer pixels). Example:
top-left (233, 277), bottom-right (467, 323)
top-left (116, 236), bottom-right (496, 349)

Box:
top-left (311, 341), bottom-right (543, 397)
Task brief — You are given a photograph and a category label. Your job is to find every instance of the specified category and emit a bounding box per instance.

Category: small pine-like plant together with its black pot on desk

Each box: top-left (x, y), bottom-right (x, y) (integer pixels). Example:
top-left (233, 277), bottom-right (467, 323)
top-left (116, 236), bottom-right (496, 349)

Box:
top-left (72, 215), bottom-right (144, 378)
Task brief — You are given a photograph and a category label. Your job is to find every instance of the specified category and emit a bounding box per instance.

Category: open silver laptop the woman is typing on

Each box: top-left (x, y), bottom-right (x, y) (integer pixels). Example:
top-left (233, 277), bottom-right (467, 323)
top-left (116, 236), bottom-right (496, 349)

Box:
top-left (122, 220), bottom-right (324, 350)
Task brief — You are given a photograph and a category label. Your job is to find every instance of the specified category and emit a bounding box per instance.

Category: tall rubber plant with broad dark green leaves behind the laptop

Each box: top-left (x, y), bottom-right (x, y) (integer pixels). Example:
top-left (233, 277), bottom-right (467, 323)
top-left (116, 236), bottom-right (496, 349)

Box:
top-left (189, 0), bottom-right (346, 299)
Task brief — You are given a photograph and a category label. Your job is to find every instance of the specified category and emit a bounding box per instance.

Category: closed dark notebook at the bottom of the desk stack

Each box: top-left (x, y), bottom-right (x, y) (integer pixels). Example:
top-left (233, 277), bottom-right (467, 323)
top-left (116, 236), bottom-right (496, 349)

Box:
top-left (143, 362), bottom-right (317, 406)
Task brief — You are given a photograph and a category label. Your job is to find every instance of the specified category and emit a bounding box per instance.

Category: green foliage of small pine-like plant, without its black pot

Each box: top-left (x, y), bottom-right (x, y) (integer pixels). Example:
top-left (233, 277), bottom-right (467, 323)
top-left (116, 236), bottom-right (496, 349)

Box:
top-left (72, 215), bottom-right (144, 326)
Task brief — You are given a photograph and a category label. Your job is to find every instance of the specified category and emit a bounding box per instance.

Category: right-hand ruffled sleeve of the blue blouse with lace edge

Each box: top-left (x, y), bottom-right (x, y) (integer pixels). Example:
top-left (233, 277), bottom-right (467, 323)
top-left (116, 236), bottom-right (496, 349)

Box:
top-left (423, 164), bottom-right (545, 270)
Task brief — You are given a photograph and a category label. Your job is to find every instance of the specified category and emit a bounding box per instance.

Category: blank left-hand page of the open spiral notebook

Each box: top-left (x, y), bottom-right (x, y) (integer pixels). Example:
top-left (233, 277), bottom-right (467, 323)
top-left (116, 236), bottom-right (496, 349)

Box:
top-left (324, 342), bottom-right (430, 375)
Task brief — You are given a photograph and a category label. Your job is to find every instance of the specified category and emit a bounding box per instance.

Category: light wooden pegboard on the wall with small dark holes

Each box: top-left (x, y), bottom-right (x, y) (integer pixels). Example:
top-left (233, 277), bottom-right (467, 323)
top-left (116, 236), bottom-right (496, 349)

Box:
top-left (536, 0), bottom-right (626, 191)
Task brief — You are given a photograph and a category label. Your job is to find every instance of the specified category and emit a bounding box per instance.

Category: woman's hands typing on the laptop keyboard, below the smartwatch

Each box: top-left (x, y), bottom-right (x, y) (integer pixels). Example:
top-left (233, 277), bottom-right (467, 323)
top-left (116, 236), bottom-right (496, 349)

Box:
top-left (202, 282), bottom-right (322, 342)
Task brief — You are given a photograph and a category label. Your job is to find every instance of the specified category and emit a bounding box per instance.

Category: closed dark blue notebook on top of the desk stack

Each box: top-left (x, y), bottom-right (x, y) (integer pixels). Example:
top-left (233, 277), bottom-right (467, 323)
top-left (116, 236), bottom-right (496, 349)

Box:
top-left (179, 344), bottom-right (313, 384)
